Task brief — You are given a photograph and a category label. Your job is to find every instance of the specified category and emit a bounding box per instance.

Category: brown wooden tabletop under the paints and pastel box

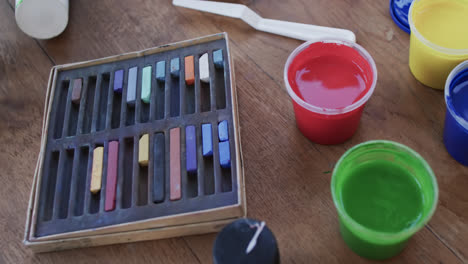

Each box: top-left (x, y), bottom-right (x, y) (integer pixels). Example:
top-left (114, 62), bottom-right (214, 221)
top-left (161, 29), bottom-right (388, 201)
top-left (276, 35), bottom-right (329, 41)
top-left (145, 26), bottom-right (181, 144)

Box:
top-left (0, 0), bottom-right (468, 263)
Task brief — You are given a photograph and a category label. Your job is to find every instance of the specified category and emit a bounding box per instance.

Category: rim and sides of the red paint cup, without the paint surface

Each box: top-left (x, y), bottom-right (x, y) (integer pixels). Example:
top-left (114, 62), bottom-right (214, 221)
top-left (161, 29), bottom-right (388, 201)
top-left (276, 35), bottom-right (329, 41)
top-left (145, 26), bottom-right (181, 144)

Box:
top-left (284, 39), bottom-right (377, 145)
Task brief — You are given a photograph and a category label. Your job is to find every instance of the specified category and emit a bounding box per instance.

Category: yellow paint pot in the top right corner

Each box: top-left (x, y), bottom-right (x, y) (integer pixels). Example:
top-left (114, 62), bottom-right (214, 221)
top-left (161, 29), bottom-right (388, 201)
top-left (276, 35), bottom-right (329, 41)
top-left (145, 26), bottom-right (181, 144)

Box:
top-left (408, 0), bottom-right (468, 89)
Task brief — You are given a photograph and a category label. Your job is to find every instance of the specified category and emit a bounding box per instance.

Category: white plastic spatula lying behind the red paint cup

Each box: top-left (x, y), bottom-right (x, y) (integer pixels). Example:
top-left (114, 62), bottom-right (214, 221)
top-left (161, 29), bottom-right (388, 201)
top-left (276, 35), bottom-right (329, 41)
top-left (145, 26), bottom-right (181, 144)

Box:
top-left (172, 0), bottom-right (356, 42)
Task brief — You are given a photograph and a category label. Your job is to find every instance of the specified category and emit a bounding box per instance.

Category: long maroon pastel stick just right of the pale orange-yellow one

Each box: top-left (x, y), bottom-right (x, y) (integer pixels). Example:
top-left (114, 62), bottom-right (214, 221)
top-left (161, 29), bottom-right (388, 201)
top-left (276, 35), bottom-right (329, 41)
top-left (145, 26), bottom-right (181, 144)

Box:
top-left (104, 141), bottom-right (119, 211)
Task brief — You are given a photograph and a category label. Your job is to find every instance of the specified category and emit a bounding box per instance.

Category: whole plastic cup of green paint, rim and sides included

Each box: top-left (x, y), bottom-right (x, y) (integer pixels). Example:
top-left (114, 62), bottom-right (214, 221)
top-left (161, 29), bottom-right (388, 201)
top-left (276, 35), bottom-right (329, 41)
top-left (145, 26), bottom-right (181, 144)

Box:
top-left (331, 140), bottom-right (439, 259)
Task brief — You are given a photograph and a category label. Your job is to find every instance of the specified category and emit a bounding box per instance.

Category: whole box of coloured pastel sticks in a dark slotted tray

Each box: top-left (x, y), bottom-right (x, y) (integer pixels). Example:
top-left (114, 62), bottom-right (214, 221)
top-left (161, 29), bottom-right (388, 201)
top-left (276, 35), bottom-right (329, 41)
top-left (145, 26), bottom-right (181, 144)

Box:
top-left (25, 34), bottom-right (245, 251)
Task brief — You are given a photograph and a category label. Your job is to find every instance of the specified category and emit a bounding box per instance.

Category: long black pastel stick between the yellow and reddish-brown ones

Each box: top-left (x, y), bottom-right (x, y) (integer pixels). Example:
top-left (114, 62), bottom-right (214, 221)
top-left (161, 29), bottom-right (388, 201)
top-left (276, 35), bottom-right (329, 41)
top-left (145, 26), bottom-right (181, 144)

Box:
top-left (153, 133), bottom-right (166, 203)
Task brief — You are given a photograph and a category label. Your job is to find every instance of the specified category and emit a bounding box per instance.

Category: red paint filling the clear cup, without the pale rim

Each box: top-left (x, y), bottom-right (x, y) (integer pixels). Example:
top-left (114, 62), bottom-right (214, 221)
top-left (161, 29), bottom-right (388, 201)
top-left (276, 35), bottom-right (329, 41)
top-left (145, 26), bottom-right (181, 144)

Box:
top-left (287, 42), bottom-right (373, 144)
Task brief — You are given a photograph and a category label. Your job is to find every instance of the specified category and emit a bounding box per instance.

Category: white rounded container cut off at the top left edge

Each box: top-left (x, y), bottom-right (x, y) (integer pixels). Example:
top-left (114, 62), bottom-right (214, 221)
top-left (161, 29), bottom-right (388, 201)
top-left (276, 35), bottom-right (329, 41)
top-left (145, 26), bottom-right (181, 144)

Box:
top-left (15, 0), bottom-right (68, 39)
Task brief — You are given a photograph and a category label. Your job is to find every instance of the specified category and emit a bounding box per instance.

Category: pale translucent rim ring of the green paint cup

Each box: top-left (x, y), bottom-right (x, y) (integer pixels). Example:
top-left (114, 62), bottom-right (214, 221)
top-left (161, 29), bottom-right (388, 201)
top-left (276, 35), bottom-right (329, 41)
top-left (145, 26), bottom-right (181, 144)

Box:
top-left (330, 140), bottom-right (439, 245)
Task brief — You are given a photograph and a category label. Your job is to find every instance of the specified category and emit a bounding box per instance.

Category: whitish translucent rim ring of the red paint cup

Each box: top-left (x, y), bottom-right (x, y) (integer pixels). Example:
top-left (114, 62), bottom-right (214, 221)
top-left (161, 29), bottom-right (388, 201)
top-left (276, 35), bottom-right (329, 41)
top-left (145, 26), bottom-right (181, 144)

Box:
top-left (283, 38), bottom-right (377, 115)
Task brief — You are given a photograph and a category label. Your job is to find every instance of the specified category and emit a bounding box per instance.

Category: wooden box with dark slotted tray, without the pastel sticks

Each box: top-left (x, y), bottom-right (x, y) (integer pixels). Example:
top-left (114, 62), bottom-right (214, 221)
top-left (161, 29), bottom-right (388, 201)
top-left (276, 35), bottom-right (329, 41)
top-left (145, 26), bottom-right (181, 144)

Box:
top-left (24, 33), bottom-right (246, 252)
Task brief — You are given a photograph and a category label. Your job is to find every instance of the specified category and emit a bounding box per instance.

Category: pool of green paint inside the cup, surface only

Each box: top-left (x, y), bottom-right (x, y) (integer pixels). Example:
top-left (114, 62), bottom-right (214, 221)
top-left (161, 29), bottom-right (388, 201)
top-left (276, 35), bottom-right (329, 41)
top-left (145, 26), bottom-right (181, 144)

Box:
top-left (341, 160), bottom-right (423, 232)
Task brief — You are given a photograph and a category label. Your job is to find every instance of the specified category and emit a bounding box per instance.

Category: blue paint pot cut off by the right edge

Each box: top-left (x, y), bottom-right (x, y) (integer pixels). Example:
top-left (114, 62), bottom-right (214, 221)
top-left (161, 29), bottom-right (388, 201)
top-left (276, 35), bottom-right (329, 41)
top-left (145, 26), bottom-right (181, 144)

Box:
top-left (444, 61), bottom-right (468, 166)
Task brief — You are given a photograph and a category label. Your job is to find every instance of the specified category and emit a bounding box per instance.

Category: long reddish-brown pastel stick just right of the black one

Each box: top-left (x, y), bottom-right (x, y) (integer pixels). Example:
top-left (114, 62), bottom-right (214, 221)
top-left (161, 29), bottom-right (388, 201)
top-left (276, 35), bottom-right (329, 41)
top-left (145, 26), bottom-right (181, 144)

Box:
top-left (169, 127), bottom-right (182, 201)
